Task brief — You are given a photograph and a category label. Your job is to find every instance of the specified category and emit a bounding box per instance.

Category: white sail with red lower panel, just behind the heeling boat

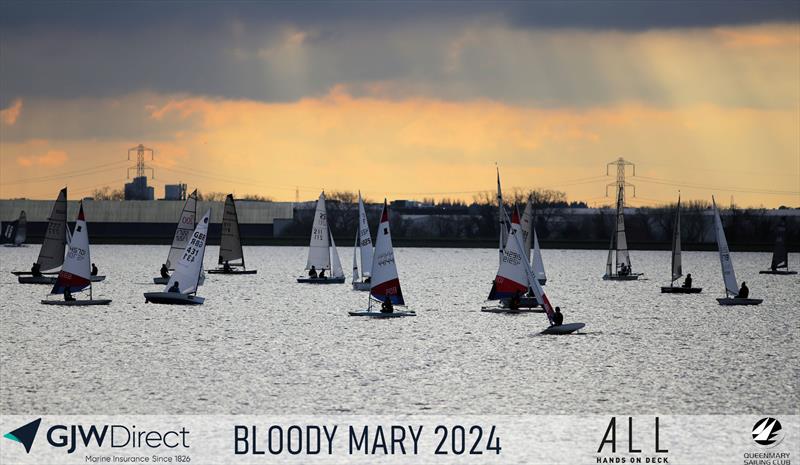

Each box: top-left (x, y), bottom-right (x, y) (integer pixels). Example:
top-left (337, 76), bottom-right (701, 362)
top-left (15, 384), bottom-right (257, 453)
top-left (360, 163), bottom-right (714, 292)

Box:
top-left (489, 208), bottom-right (528, 300)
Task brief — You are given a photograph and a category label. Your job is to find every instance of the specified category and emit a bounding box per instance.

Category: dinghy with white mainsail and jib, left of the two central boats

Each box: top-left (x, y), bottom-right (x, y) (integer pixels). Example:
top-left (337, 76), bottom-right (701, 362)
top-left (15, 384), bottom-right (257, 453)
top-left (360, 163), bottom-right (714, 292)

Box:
top-left (297, 191), bottom-right (344, 284)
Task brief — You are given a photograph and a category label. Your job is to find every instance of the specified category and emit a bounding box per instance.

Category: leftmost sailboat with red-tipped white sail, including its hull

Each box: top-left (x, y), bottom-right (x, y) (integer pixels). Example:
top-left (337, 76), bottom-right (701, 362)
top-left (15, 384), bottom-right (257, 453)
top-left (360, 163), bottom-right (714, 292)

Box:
top-left (42, 202), bottom-right (111, 306)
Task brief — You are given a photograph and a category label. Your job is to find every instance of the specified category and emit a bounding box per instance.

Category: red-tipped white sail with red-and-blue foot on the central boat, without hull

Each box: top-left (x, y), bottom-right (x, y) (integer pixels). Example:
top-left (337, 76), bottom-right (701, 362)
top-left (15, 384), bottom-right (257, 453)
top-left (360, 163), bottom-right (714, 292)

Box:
top-left (369, 199), bottom-right (405, 305)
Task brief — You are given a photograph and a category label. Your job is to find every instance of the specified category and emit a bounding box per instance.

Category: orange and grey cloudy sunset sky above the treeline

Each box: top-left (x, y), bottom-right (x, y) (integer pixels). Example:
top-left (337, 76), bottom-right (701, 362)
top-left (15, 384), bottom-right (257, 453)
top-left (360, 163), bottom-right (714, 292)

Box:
top-left (0, 1), bottom-right (800, 207)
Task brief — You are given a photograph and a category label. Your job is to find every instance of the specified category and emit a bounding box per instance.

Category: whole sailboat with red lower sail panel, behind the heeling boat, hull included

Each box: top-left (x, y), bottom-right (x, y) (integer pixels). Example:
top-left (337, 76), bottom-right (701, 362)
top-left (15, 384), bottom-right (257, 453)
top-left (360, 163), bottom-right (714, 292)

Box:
top-left (481, 208), bottom-right (545, 313)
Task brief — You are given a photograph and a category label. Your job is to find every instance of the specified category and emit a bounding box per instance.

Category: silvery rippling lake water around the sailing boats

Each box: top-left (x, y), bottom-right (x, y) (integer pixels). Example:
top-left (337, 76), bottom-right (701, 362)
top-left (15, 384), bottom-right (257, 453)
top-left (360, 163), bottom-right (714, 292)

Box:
top-left (0, 245), bottom-right (800, 415)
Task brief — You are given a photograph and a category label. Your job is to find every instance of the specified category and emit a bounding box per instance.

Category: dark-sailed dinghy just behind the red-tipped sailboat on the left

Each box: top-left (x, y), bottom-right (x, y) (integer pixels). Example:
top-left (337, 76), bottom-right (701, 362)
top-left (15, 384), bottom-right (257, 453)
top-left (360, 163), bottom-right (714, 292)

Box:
top-left (13, 187), bottom-right (67, 284)
